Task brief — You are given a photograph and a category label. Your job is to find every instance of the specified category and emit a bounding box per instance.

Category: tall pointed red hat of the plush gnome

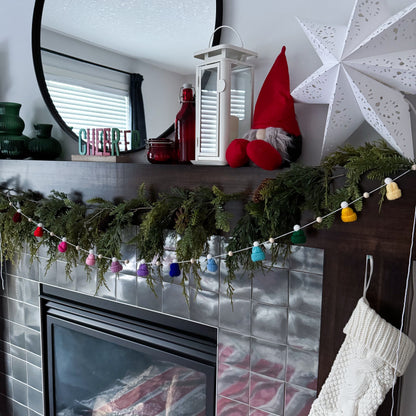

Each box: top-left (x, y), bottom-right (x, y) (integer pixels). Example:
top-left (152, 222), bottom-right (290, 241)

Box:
top-left (251, 46), bottom-right (300, 136)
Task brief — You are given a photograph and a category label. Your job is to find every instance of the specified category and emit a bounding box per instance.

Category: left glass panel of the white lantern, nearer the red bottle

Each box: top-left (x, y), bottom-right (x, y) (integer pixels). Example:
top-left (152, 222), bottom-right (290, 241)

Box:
top-left (199, 66), bottom-right (219, 156)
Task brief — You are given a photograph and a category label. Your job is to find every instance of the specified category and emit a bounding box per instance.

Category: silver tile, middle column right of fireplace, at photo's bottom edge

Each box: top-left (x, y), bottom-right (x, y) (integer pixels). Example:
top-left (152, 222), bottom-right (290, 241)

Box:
top-left (250, 374), bottom-right (285, 415)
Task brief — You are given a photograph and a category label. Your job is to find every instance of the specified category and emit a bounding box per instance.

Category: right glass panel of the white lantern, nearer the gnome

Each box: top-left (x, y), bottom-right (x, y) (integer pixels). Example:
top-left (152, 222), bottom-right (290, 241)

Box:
top-left (230, 64), bottom-right (253, 137)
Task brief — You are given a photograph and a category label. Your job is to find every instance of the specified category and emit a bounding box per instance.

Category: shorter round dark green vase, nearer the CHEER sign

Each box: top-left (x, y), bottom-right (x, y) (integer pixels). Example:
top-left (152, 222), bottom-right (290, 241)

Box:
top-left (28, 124), bottom-right (62, 160)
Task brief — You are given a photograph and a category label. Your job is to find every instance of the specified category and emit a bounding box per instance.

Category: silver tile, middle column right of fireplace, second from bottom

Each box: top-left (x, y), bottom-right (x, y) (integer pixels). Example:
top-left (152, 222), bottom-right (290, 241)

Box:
top-left (250, 338), bottom-right (287, 380)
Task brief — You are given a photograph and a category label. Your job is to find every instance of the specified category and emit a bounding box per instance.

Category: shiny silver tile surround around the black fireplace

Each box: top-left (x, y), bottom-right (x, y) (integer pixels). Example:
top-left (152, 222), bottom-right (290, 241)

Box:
top-left (0, 236), bottom-right (323, 416)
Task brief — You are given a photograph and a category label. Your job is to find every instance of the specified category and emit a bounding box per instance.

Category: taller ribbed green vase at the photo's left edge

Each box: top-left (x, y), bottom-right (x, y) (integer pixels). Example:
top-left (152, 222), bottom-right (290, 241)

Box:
top-left (0, 102), bottom-right (29, 159)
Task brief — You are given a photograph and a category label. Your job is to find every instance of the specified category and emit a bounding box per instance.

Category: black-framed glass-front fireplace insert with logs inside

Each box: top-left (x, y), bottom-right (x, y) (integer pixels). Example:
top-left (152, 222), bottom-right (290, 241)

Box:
top-left (41, 285), bottom-right (217, 416)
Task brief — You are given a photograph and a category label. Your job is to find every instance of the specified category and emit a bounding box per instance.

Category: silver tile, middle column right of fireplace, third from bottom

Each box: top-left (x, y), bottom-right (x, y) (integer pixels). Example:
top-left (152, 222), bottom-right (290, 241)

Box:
top-left (251, 302), bottom-right (287, 344)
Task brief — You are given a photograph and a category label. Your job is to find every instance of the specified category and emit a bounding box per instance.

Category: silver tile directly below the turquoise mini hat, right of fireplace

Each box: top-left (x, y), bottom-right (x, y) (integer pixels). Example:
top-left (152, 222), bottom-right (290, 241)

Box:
top-left (253, 268), bottom-right (289, 306)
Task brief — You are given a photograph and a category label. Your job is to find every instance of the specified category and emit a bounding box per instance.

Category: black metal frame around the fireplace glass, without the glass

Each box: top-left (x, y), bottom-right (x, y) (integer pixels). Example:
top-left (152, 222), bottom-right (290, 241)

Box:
top-left (40, 284), bottom-right (217, 416)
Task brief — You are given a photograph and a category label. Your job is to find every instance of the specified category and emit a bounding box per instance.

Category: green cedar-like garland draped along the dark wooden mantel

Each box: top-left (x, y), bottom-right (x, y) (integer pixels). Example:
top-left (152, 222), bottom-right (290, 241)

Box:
top-left (0, 141), bottom-right (413, 297)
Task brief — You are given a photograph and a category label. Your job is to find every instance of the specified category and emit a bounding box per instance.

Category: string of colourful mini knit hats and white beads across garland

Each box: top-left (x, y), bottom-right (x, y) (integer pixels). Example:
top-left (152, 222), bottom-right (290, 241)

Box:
top-left (5, 164), bottom-right (416, 277)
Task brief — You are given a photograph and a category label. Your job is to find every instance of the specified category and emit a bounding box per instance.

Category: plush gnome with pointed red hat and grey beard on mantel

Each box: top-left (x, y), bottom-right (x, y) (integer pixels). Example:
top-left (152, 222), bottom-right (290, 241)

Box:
top-left (225, 46), bottom-right (302, 170)
